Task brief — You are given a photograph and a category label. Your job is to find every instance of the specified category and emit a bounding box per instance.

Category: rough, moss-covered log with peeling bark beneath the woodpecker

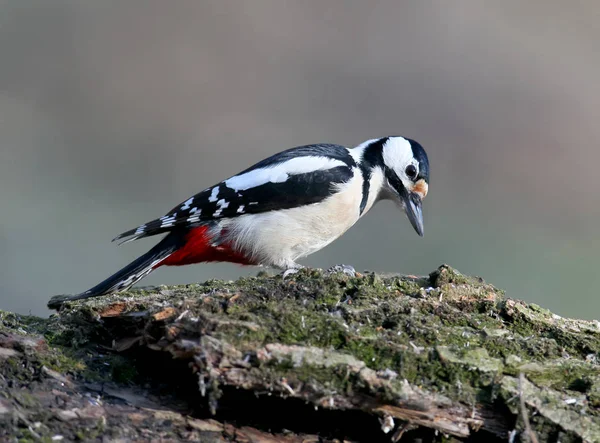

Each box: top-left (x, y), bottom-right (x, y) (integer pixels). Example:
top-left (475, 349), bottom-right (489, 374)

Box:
top-left (0, 266), bottom-right (600, 443)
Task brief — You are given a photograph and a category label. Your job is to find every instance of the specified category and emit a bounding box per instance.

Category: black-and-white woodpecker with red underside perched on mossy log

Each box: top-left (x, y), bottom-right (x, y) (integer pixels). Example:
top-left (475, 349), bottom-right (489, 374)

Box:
top-left (49, 136), bottom-right (429, 306)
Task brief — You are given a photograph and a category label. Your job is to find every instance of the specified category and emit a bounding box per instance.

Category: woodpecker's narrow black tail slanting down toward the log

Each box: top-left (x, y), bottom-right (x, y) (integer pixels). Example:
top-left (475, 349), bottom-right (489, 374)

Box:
top-left (48, 231), bottom-right (185, 309)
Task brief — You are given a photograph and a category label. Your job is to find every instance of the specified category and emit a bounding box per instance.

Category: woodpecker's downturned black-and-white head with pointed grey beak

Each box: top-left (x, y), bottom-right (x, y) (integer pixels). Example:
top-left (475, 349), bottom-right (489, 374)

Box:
top-left (382, 137), bottom-right (429, 237)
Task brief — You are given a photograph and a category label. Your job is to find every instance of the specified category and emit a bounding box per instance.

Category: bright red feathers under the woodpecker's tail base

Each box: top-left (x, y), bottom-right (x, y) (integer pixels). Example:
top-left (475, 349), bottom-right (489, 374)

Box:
top-left (155, 226), bottom-right (253, 268)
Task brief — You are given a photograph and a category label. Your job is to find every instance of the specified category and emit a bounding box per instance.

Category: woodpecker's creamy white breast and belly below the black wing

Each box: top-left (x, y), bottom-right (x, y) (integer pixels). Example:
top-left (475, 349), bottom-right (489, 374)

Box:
top-left (220, 169), bottom-right (364, 269)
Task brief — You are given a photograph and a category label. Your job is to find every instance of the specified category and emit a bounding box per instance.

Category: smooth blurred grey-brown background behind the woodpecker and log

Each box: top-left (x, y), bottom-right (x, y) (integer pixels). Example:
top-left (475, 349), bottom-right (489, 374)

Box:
top-left (0, 0), bottom-right (600, 319)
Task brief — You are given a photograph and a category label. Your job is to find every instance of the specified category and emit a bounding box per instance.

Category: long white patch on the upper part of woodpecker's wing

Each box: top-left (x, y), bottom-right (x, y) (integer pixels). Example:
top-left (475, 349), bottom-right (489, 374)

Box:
top-left (224, 156), bottom-right (346, 192)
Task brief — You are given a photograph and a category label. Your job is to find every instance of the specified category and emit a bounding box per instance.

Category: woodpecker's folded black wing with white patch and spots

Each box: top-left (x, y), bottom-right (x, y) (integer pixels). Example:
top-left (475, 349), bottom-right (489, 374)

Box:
top-left (113, 145), bottom-right (356, 243)
